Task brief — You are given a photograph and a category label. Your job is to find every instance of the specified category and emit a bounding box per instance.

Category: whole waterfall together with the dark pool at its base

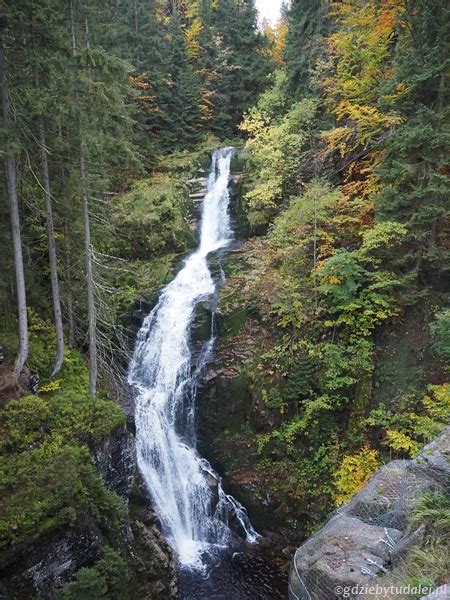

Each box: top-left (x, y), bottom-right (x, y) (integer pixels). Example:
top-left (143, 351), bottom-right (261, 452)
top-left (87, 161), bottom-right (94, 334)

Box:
top-left (128, 148), bottom-right (284, 600)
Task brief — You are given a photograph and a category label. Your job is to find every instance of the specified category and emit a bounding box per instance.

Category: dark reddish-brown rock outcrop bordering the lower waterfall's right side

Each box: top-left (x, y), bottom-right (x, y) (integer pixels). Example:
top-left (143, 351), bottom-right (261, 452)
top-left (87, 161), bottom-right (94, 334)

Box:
top-left (197, 328), bottom-right (299, 552)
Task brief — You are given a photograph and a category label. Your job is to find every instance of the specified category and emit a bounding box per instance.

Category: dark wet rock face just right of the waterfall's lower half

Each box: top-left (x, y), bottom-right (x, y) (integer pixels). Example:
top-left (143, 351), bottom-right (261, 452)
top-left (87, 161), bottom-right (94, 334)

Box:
top-left (197, 358), bottom-right (298, 560)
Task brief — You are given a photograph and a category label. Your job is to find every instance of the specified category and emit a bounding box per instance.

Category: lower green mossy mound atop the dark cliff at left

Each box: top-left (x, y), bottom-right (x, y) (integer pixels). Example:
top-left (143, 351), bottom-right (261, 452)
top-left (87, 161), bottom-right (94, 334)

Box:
top-left (0, 446), bottom-right (123, 548)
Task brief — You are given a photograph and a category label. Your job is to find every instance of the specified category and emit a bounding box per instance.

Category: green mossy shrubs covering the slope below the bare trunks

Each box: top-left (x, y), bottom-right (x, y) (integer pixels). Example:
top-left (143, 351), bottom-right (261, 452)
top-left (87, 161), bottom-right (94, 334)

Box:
top-left (0, 340), bottom-right (125, 548)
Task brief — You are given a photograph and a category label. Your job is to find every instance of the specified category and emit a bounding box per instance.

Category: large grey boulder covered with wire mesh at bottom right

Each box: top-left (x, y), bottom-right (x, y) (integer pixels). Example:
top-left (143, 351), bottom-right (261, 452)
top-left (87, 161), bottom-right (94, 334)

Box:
top-left (290, 429), bottom-right (450, 600)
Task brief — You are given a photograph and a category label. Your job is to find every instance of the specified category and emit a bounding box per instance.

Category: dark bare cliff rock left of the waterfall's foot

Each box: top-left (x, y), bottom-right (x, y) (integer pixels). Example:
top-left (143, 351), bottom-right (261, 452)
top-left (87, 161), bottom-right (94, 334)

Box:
top-left (0, 426), bottom-right (176, 600)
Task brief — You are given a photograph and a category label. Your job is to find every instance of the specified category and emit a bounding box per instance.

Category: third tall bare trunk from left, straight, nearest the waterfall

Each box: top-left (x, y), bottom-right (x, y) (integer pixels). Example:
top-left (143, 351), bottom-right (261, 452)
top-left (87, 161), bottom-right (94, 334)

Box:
top-left (70, 0), bottom-right (98, 396)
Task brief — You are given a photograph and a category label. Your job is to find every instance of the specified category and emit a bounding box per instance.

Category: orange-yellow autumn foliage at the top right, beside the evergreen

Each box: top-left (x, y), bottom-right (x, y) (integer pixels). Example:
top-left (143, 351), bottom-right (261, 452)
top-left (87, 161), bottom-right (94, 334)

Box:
top-left (322, 0), bottom-right (407, 198)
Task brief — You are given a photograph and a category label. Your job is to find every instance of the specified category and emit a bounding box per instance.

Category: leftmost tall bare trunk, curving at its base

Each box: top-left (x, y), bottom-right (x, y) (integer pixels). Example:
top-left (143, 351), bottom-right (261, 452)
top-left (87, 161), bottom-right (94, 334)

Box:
top-left (0, 25), bottom-right (28, 379)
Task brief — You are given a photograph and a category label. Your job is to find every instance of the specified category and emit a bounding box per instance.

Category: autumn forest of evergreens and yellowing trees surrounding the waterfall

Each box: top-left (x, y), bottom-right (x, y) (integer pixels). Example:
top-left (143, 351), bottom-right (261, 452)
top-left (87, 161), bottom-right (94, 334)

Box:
top-left (0, 0), bottom-right (450, 600)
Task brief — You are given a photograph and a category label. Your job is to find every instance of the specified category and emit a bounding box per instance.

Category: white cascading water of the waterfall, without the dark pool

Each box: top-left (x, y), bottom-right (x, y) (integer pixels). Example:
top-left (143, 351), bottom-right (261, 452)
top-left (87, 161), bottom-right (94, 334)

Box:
top-left (128, 148), bottom-right (258, 568)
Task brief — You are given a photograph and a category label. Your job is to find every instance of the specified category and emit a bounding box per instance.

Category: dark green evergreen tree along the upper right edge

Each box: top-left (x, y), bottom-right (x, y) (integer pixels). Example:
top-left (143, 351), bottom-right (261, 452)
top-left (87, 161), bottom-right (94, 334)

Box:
top-left (377, 0), bottom-right (450, 288)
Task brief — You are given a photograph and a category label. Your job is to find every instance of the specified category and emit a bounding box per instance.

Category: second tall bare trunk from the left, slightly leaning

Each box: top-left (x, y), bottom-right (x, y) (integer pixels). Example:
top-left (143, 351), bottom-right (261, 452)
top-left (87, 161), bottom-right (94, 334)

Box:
top-left (38, 118), bottom-right (64, 377)
